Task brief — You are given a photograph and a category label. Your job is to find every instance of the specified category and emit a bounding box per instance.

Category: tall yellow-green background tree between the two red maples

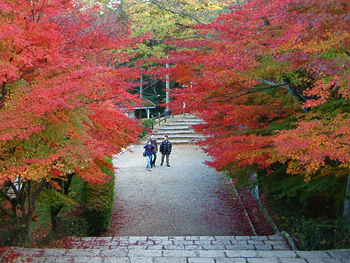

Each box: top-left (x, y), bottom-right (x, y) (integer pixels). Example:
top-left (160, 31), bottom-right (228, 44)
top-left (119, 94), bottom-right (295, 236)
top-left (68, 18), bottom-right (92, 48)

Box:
top-left (115, 0), bottom-right (234, 104)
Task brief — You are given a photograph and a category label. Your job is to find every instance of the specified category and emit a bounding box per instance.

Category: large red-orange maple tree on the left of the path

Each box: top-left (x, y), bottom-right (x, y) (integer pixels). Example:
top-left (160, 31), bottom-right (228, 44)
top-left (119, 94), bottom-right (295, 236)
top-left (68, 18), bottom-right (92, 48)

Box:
top-left (0, 0), bottom-right (143, 242)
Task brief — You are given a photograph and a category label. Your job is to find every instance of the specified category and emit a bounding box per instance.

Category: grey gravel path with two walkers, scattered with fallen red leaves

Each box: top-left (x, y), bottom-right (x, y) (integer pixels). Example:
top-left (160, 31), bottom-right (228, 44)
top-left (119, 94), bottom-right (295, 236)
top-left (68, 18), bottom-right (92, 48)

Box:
top-left (106, 145), bottom-right (245, 236)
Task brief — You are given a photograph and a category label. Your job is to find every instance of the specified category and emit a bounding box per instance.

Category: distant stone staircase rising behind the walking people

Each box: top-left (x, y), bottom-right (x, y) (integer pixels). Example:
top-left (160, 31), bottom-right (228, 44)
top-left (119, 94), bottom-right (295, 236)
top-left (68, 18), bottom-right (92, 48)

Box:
top-left (153, 115), bottom-right (205, 144)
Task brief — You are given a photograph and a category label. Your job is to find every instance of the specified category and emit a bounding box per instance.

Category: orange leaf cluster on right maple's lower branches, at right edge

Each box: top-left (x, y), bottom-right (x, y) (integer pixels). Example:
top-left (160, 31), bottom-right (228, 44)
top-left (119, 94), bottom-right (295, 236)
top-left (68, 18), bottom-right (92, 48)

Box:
top-left (274, 113), bottom-right (350, 182)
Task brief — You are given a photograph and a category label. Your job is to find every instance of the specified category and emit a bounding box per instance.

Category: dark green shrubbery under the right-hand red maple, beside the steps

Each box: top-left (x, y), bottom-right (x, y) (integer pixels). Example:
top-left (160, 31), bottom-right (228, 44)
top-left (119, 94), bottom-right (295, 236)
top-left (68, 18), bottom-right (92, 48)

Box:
top-left (258, 167), bottom-right (350, 250)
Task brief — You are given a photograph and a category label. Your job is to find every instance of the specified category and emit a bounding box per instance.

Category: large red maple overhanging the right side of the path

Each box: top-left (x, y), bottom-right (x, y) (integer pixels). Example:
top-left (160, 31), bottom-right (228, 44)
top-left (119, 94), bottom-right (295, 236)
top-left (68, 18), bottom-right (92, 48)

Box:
top-left (161, 0), bottom-right (350, 212)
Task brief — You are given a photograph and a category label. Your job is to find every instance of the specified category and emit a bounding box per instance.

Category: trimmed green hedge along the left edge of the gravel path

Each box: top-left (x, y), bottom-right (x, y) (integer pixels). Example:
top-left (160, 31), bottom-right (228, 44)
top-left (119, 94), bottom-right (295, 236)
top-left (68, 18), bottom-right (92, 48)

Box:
top-left (84, 163), bottom-right (114, 235)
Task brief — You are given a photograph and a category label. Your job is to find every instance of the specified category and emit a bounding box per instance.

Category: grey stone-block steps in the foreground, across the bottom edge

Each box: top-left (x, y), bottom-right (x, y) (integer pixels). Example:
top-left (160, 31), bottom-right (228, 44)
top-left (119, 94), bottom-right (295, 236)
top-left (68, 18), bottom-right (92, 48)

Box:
top-left (0, 234), bottom-right (350, 263)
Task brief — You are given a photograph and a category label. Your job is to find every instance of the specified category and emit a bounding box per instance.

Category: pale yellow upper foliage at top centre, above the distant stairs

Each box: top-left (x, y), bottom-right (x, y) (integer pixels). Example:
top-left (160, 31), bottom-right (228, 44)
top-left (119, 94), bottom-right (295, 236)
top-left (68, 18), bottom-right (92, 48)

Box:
top-left (124, 0), bottom-right (226, 40)
